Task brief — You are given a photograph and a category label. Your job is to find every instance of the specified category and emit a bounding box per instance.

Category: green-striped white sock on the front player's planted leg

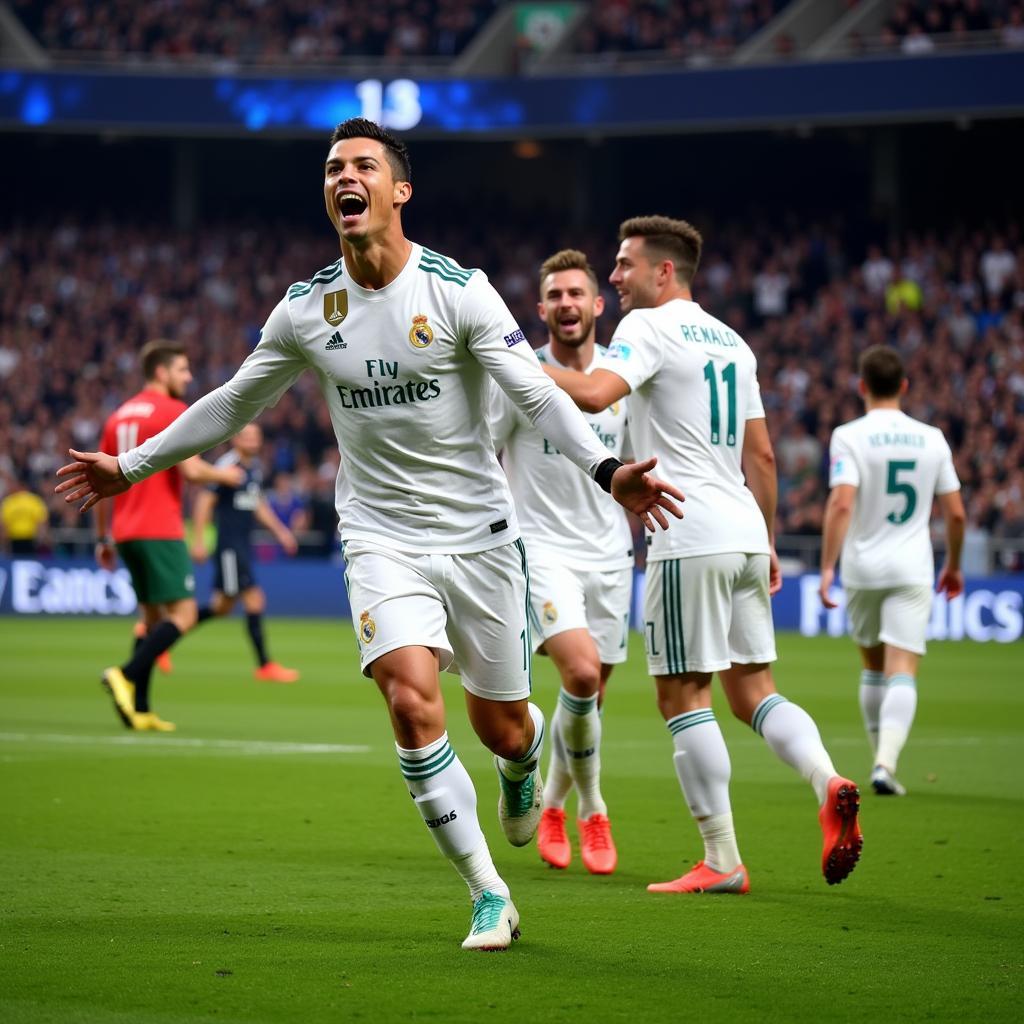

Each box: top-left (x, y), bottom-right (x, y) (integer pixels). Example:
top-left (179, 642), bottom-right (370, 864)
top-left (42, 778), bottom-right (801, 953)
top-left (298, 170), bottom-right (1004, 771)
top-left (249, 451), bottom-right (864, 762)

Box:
top-left (395, 732), bottom-right (509, 900)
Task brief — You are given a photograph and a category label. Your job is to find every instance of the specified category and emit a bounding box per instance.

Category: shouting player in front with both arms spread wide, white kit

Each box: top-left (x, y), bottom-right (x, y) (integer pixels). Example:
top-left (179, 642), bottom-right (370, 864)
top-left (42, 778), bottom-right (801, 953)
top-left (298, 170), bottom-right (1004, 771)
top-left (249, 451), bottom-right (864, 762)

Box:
top-left (57, 118), bottom-right (682, 949)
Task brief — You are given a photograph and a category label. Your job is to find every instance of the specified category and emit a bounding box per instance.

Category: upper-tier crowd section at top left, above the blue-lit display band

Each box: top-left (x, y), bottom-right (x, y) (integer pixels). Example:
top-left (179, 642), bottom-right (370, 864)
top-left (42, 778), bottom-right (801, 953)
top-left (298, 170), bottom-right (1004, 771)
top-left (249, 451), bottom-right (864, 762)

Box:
top-left (11, 0), bottom-right (500, 63)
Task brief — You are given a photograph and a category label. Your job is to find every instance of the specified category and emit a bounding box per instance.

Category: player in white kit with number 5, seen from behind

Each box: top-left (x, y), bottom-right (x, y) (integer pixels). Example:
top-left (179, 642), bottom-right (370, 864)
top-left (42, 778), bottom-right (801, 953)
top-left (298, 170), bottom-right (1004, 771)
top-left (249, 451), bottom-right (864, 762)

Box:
top-left (820, 345), bottom-right (966, 797)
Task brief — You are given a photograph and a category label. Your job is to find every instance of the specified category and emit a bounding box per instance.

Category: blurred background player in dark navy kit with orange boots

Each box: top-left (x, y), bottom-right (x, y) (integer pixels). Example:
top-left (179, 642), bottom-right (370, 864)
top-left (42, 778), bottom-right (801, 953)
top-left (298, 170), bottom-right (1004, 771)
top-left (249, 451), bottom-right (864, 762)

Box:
top-left (191, 423), bottom-right (299, 683)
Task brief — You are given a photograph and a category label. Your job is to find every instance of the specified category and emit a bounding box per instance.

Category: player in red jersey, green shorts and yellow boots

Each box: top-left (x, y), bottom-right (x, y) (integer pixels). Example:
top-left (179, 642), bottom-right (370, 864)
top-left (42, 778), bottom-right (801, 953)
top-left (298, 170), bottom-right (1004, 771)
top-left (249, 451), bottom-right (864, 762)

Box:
top-left (96, 341), bottom-right (242, 732)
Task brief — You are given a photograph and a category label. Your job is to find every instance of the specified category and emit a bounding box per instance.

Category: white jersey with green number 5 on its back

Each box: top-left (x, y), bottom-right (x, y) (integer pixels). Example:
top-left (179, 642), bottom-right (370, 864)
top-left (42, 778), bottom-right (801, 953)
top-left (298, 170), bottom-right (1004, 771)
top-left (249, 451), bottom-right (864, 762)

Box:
top-left (828, 409), bottom-right (959, 589)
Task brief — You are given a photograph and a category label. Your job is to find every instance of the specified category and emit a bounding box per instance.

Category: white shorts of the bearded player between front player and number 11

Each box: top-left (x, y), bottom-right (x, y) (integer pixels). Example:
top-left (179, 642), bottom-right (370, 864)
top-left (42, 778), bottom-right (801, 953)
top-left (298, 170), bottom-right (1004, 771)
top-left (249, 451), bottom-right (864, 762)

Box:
top-left (529, 548), bottom-right (633, 665)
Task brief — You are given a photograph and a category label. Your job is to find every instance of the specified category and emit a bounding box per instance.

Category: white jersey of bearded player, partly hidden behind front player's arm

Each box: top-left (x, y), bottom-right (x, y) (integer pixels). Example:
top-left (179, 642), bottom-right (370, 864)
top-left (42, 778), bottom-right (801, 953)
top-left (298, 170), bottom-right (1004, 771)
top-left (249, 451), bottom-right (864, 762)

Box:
top-left (489, 345), bottom-right (633, 572)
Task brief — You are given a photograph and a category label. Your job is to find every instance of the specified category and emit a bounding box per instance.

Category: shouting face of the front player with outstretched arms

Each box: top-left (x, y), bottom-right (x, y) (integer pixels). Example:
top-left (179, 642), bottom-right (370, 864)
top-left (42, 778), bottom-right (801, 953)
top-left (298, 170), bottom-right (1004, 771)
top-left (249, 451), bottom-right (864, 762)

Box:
top-left (324, 138), bottom-right (413, 247)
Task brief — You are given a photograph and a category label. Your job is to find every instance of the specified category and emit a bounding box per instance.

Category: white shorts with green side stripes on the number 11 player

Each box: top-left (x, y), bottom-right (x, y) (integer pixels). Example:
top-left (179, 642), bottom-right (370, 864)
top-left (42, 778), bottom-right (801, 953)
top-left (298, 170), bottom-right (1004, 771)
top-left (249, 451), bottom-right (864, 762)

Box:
top-left (644, 552), bottom-right (776, 676)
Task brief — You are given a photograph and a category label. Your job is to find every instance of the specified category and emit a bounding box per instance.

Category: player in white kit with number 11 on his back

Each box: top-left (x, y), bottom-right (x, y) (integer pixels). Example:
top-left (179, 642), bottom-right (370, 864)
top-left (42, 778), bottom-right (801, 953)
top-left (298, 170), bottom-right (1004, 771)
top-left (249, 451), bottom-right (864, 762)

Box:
top-left (545, 217), bottom-right (862, 893)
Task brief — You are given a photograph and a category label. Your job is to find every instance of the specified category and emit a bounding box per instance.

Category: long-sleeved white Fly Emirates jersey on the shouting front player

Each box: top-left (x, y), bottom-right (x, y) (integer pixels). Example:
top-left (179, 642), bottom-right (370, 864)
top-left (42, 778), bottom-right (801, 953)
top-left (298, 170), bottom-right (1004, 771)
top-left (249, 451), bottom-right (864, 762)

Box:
top-left (120, 245), bottom-right (608, 554)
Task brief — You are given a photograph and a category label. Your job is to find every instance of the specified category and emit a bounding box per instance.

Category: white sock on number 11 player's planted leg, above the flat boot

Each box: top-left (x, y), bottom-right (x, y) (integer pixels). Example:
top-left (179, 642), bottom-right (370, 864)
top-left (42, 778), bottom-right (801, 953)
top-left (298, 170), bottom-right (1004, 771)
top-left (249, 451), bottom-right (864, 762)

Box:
top-left (666, 708), bottom-right (741, 872)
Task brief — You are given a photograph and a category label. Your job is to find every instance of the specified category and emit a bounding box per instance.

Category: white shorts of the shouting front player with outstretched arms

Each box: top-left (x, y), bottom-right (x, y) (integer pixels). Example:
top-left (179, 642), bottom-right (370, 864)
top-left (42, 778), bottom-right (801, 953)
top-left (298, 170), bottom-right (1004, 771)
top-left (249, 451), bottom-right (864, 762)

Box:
top-left (344, 541), bottom-right (532, 700)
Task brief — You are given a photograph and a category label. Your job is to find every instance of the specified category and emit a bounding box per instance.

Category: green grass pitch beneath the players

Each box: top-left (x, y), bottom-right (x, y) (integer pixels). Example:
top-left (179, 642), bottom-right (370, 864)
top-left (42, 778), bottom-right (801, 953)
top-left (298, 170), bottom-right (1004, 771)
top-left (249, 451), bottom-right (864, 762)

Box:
top-left (0, 618), bottom-right (1024, 1024)
